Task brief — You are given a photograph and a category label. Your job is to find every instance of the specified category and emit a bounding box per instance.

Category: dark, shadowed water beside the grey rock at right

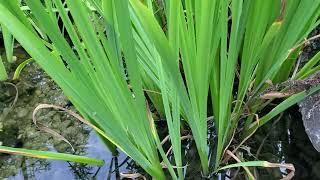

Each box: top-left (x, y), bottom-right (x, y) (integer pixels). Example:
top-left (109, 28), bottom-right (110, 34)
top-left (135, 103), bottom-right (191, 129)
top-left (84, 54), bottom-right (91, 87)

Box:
top-left (250, 106), bottom-right (320, 180)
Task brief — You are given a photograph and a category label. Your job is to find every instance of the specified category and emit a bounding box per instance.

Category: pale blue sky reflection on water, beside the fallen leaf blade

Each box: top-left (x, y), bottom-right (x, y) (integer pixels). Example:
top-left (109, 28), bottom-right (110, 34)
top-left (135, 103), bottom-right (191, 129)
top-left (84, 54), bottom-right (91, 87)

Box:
top-left (8, 132), bottom-right (128, 180)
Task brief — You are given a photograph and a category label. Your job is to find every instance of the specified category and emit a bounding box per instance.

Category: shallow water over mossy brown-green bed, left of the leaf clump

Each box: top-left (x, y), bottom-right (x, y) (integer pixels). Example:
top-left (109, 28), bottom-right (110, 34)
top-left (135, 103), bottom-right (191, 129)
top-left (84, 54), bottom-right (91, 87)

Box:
top-left (0, 56), bottom-right (134, 180)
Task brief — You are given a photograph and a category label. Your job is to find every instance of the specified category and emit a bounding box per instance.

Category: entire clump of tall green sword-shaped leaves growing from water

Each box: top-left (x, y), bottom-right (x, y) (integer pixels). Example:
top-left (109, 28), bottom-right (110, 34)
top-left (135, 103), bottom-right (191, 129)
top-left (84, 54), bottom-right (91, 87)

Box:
top-left (0, 0), bottom-right (320, 179)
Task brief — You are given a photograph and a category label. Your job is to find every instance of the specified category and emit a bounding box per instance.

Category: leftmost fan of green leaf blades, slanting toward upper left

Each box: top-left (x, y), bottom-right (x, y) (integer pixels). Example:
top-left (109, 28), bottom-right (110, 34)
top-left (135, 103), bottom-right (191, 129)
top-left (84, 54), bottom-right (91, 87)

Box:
top-left (0, 0), bottom-right (163, 177)
